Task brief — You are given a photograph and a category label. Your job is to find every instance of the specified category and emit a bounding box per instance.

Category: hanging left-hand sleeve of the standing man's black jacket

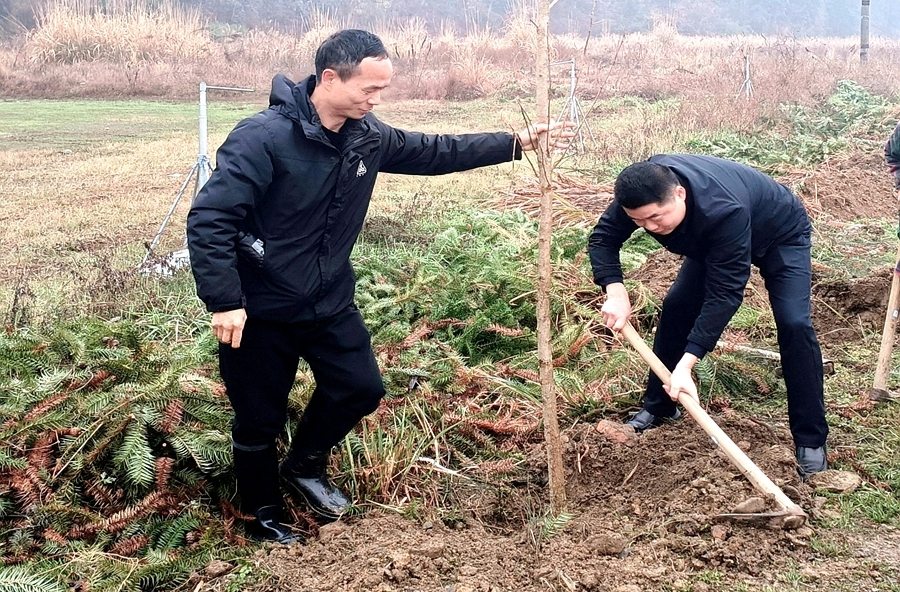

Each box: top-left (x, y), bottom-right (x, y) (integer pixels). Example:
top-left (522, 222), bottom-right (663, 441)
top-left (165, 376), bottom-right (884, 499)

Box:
top-left (187, 120), bottom-right (273, 312)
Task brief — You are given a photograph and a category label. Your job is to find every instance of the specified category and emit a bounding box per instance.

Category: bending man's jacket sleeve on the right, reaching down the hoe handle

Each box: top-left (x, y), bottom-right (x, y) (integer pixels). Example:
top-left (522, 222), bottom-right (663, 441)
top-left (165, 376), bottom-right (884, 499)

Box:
top-left (685, 208), bottom-right (751, 358)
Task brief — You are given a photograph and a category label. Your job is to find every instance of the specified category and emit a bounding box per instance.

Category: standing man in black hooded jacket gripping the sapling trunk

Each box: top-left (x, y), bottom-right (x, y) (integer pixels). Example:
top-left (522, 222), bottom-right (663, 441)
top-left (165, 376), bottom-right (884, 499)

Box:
top-left (188, 30), bottom-right (573, 543)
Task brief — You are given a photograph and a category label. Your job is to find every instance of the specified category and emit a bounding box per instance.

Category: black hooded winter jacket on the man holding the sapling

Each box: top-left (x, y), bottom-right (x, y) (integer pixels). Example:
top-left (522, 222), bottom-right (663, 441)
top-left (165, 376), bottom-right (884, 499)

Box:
top-left (187, 75), bottom-right (521, 322)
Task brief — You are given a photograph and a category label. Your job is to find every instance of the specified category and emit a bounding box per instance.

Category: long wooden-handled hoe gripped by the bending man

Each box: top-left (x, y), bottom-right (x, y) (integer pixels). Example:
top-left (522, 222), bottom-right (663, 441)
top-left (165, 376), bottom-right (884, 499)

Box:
top-left (621, 323), bottom-right (807, 529)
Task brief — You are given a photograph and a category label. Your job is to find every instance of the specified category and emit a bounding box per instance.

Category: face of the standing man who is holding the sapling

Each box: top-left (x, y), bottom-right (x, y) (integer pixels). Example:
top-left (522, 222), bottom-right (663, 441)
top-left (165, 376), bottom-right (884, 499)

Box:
top-left (321, 58), bottom-right (394, 119)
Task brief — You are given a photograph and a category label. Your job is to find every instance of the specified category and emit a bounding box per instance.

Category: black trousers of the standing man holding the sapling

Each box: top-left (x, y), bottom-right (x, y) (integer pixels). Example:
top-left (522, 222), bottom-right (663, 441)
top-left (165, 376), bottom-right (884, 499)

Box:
top-left (219, 305), bottom-right (385, 513)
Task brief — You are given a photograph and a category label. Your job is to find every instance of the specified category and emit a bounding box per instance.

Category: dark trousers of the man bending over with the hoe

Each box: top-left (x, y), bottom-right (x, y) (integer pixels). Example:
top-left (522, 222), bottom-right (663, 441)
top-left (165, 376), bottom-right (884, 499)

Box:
top-left (644, 236), bottom-right (828, 448)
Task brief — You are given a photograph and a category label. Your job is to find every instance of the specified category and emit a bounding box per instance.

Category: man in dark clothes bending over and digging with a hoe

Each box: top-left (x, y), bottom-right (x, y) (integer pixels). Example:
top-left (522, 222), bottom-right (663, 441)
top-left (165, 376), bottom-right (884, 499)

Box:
top-left (589, 154), bottom-right (828, 477)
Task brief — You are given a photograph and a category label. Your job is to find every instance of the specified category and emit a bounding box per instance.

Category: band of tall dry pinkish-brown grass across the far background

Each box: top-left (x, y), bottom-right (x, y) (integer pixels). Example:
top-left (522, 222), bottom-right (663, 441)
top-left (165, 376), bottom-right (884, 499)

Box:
top-left (0, 0), bottom-right (900, 129)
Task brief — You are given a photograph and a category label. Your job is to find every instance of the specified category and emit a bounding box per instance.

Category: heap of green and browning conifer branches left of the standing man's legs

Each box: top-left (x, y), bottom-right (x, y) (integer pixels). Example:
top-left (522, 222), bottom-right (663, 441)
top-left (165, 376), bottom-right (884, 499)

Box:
top-left (0, 321), bottom-right (239, 592)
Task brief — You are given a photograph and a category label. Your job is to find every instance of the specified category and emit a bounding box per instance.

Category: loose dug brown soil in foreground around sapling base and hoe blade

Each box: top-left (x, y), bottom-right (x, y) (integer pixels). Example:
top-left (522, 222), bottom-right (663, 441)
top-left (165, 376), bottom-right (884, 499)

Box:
top-left (197, 414), bottom-right (900, 592)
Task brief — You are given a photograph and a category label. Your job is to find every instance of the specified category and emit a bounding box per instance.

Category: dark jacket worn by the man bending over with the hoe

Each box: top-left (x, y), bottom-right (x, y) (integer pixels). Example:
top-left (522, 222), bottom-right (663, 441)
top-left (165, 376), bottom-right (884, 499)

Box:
top-left (588, 154), bottom-right (811, 357)
